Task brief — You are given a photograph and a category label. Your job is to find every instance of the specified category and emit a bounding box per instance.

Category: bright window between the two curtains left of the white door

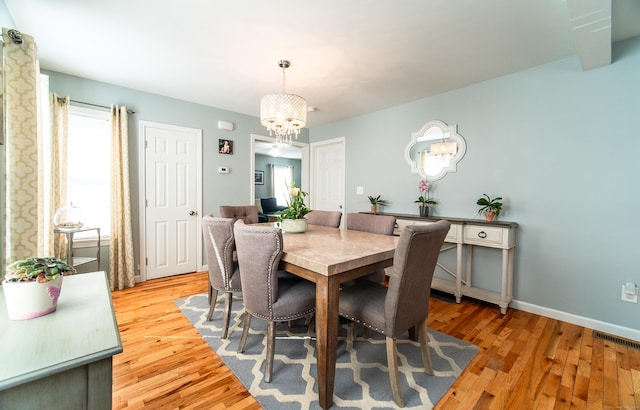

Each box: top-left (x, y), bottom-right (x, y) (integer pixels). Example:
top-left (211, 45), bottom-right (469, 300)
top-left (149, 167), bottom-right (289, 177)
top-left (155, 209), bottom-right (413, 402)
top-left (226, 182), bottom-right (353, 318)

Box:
top-left (67, 106), bottom-right (111, 239)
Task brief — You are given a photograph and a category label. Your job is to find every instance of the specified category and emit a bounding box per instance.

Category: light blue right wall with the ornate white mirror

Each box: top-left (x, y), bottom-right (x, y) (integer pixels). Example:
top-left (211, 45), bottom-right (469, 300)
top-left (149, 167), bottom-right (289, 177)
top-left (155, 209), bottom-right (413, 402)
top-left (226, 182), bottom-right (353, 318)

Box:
top-left (310, 38), bottom-right (640, 329)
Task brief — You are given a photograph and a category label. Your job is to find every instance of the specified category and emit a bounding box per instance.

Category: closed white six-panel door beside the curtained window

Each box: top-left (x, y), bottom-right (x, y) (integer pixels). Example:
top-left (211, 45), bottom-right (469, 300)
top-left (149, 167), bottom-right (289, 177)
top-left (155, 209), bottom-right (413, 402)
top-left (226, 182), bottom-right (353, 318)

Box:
top-left (141, 123), bottom-right (202, 279)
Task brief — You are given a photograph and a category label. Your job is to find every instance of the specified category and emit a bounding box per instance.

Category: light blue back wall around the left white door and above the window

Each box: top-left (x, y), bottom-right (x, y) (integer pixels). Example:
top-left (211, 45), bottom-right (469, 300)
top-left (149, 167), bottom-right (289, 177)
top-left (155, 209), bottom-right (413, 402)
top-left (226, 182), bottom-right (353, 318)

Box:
top-left (42, 70), bottom-right (309, 265)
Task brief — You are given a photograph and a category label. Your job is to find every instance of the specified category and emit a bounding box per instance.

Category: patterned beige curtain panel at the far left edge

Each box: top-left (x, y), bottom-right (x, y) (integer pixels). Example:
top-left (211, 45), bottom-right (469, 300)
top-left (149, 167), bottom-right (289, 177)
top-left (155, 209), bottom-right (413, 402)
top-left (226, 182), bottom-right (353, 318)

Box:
top-left (2, 28), bottom-right (43, 266)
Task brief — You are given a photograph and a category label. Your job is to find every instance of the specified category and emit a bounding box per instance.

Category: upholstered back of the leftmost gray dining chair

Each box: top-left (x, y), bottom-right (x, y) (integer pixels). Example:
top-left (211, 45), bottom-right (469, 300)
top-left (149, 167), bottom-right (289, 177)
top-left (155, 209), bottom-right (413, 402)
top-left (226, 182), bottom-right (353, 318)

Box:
top-left (202, 215), bottom-right (242, 292)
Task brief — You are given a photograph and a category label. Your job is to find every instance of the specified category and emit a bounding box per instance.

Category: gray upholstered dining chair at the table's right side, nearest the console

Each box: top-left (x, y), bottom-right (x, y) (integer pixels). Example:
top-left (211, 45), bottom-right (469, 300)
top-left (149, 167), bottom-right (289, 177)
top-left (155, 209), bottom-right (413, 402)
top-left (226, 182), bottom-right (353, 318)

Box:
top-left (339, 220), bottom-right (450, 407)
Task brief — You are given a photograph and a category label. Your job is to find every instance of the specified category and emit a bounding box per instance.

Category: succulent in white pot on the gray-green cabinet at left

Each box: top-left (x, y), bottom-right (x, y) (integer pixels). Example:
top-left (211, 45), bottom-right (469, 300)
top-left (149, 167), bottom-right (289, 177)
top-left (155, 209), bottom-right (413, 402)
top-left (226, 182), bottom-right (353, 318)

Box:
top-left (2, 257), bottom-right (76, 320)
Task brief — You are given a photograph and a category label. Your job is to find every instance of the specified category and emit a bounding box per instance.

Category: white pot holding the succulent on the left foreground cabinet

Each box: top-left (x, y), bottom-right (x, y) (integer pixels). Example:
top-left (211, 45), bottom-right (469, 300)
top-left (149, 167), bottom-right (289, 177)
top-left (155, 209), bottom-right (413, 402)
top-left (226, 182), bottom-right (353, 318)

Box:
top-left (2, 275), bottom-right (62, 320)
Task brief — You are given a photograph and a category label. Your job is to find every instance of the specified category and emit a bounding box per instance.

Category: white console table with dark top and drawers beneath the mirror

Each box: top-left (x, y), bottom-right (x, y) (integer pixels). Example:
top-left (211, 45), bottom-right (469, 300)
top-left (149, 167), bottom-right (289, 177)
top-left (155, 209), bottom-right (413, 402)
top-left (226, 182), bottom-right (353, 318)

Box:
top-left (368, 213), bottom-right (518, 314)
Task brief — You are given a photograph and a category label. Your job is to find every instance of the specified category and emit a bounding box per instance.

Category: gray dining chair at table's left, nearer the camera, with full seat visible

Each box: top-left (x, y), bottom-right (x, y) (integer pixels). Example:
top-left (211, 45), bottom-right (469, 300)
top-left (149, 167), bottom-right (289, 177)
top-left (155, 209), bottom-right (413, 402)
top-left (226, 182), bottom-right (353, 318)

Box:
top-left (234, 220), bottom-right (316, 383)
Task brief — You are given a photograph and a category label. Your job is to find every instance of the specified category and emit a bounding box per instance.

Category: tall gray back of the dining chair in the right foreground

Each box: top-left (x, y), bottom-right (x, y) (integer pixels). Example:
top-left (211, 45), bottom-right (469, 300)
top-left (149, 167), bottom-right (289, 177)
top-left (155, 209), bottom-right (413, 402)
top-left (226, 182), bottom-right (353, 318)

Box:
top-left (384, 220), bottom-right (451, 337)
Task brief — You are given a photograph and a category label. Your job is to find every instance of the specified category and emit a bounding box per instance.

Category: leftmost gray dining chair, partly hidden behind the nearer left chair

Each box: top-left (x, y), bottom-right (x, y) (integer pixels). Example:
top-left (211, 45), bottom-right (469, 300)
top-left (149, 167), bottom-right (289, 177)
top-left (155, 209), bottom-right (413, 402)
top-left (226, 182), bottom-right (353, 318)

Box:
top-left (202, 215), bottom-right (242, 339)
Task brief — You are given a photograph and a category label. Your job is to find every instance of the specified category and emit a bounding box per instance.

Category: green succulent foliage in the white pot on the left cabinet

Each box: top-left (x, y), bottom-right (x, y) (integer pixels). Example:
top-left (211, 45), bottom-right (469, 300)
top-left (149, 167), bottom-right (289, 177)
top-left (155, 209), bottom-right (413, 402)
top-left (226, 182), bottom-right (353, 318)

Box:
top-left (4, 256), bottom-right (76, 283)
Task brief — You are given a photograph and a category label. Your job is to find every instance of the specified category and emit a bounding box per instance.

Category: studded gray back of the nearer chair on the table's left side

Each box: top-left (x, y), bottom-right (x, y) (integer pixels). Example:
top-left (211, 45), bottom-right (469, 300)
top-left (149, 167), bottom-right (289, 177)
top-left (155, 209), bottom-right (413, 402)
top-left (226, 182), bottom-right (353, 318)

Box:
top-left (234, 220), bottom-right (283, 320)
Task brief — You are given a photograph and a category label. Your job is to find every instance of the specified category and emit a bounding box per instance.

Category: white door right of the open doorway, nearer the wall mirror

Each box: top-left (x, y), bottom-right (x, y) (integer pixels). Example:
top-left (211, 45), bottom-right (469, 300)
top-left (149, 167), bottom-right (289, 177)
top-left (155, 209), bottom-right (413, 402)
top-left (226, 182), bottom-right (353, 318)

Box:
top-left (310, 137), bottom-right (345, 219)
